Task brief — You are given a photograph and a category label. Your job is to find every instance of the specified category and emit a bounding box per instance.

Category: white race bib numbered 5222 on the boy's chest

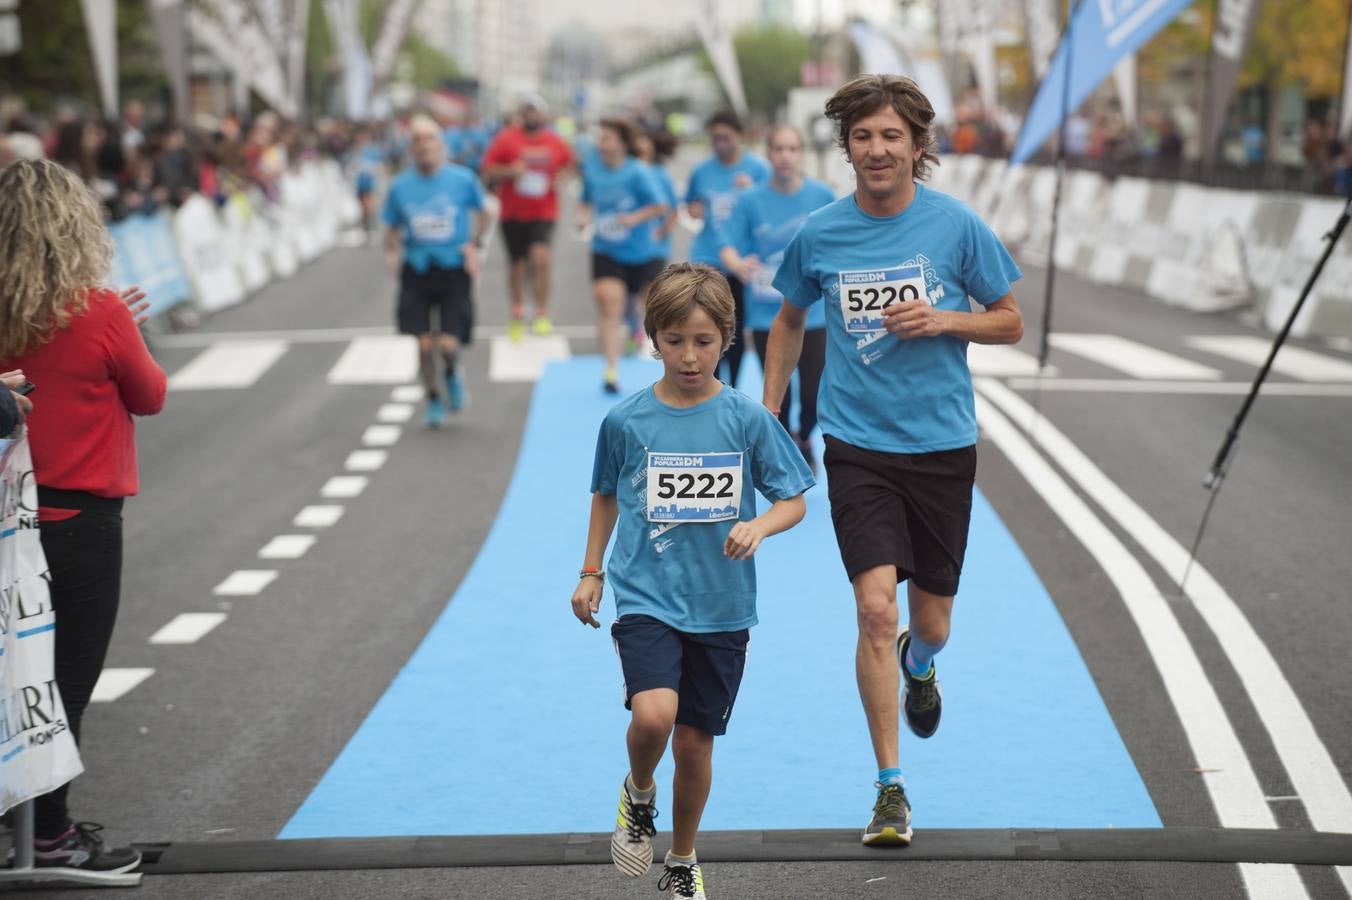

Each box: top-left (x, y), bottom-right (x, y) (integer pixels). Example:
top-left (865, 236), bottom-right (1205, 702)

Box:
top-left (648, 453), bottom-right (742, 522)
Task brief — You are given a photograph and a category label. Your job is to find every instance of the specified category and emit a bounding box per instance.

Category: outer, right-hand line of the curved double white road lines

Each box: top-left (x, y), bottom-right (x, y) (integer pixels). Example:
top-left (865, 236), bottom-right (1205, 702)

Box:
top-left (979, 378), bottom-right (1352, 893)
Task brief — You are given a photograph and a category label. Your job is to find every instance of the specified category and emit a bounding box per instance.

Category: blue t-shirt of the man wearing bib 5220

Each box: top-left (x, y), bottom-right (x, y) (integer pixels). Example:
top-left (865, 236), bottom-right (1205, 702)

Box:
top-left (775, 182), bottom-right (1022, 453)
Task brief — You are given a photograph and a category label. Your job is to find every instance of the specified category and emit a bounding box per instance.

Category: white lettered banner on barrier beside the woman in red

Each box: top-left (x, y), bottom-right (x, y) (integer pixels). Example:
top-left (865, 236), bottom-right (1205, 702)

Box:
top-left (0, 438), bottom-right (84, 814)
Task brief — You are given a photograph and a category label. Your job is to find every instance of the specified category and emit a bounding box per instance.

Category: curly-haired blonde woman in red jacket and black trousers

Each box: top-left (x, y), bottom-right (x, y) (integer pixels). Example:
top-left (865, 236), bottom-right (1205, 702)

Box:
top-left (0, 159), bottom-right (166, 872)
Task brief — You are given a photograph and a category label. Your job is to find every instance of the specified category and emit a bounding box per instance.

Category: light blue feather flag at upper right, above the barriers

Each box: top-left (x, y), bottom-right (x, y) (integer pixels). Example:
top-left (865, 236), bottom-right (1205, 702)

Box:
top-left (1010, 0), bottom-right (1192, 165)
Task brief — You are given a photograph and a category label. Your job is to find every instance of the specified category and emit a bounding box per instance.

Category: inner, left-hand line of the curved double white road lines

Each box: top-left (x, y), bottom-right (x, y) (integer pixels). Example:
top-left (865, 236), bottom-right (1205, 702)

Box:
top-left (976, 396), bottom-right (1309, 897)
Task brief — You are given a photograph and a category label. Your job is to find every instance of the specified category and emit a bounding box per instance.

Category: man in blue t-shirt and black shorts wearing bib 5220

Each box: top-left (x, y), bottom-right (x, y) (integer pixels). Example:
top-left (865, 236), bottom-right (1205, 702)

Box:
top-left (764, 74), bottom-right (1023, 845)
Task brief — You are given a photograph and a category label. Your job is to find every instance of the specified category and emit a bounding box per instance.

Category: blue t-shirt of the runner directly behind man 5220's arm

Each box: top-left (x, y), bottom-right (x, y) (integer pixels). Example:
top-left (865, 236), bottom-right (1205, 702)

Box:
top-left (723, 178), bottom-right (836, 331)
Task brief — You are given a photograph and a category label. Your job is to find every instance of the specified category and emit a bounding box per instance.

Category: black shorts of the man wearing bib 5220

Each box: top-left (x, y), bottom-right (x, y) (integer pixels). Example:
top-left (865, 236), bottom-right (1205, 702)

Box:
top-left (823, 435), bottom-right (976, 597)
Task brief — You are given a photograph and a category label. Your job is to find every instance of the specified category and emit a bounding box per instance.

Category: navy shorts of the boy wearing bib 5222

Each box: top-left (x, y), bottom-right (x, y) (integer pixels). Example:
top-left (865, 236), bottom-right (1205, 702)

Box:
top-left (610, 615), bottom-right (750, 735)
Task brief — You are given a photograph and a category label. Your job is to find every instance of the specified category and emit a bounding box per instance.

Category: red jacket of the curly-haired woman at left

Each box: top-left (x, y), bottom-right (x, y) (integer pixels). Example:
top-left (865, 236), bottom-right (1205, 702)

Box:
top-left (0, 289), bottom-right (168, 510)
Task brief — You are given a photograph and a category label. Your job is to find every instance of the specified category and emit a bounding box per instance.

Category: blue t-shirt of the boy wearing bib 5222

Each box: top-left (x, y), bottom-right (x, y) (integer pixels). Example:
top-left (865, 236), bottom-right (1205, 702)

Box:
top-left (592, 385), bottom-right (814, 632)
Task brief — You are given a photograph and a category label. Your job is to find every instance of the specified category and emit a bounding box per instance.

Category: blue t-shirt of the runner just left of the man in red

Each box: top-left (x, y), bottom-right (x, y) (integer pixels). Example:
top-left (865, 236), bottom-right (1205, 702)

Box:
top-left (381, 162), bottom-right (484, 273)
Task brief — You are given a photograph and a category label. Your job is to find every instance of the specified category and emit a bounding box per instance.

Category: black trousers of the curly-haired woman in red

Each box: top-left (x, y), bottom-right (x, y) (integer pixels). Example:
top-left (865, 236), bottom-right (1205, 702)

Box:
top-left (32, 493), bottom-right (122, 839)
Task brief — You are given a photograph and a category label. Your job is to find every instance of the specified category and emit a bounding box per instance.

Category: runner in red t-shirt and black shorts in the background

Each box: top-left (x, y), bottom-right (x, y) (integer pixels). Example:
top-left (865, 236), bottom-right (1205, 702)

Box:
top-left (483, 95), bottom-right (573, 341)
